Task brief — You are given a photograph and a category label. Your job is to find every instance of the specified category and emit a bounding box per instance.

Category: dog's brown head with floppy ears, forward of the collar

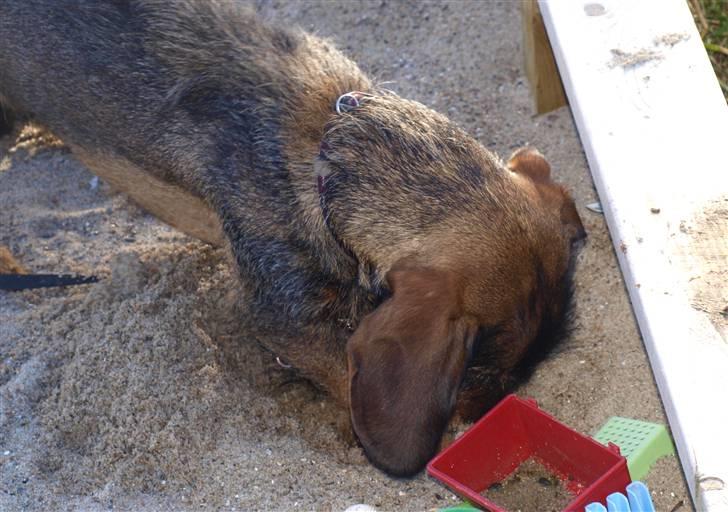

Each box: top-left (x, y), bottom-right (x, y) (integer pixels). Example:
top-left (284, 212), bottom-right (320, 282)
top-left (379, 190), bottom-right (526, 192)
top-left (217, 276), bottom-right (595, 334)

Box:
top-left (317, 96), bottom-right (585, 476)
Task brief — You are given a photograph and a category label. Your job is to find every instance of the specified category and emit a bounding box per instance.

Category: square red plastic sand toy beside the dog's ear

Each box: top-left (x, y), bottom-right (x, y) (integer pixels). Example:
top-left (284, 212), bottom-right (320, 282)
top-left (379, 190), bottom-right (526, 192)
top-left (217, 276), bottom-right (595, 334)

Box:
top-left (427, 395), bottom-right (631, 512)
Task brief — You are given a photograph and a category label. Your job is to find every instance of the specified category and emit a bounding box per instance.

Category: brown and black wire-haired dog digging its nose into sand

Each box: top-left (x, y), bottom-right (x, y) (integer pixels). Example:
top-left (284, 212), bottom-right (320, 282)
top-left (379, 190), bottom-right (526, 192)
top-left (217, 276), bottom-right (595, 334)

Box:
top-left (0, 0), bottom-right (586, 476)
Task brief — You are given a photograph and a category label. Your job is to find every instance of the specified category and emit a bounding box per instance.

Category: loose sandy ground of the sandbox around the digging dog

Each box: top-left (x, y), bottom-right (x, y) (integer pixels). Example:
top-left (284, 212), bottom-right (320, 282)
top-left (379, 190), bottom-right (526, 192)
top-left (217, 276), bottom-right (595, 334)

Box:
top-left (0, 0), bottom-right (690, 511)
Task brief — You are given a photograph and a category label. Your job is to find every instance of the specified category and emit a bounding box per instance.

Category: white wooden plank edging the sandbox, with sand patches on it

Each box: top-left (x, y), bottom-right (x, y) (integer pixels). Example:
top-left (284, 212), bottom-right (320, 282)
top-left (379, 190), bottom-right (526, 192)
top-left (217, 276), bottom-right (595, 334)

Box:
top-left (539, 0), bottom-right (728, 511)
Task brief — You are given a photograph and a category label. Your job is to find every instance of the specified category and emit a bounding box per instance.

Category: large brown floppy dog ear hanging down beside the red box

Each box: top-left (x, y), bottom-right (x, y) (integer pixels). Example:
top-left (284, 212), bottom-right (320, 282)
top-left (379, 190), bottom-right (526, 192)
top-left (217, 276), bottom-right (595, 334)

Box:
top-left (347, 269), bottom-right (476, 476)
